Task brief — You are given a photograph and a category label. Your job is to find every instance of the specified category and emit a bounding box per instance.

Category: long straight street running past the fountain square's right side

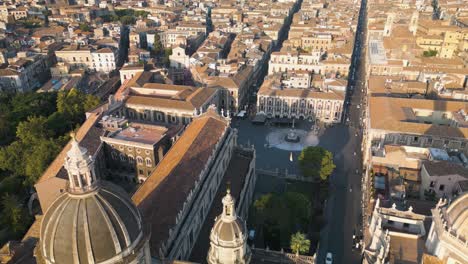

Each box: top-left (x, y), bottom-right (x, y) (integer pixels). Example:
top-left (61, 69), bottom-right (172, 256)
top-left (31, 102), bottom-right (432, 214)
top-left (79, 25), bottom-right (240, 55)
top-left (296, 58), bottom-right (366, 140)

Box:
top-left (317, 0), bottom-right (367, 264)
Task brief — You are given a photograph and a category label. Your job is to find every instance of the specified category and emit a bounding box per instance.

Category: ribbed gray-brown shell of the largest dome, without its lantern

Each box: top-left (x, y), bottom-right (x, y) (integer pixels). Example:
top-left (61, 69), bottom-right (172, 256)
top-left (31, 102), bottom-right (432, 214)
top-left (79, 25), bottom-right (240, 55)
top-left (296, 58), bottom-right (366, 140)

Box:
top-left (40, 182), bottom-right (144, 263)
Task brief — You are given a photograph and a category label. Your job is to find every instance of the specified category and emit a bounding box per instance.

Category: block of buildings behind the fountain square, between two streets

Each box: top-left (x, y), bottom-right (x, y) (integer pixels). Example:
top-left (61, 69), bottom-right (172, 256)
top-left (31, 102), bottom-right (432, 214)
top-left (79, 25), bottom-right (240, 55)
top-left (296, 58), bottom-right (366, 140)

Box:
top-left (256, 1), bottom-right (359, 123)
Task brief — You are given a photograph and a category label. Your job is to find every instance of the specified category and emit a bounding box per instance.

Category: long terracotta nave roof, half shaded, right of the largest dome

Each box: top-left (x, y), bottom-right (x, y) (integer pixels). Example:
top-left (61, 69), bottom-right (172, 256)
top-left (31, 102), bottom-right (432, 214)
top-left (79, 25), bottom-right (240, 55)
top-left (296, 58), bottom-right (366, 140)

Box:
top-left (132, 110), bottom-right (229, 255)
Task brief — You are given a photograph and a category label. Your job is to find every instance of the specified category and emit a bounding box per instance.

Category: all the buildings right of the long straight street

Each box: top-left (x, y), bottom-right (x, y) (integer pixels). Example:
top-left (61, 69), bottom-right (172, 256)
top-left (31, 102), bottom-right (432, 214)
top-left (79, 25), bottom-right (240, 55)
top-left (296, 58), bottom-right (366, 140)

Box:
top-left (362, 1), bottom-right (468, 263)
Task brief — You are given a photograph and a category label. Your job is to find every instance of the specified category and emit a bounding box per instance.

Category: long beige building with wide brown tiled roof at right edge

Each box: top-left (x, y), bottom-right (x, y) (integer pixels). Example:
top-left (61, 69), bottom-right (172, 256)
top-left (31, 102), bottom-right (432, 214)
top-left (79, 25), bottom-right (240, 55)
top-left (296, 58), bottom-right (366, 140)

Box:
top-left (366, 97), bottom-right (468, 162)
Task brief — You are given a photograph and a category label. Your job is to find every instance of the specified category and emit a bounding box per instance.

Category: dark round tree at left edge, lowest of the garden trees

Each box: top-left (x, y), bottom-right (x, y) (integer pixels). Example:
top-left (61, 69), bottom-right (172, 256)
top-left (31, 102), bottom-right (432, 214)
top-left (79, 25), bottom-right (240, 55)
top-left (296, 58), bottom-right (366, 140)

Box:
top-left (1, 194), bottom-right (30, 234)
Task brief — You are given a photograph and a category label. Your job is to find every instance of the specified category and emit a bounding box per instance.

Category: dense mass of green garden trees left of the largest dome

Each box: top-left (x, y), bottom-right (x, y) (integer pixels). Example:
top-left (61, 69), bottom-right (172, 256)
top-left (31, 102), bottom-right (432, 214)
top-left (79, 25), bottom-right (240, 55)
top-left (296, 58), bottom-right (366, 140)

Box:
top-left (0, 89), bottom-right (99, 244)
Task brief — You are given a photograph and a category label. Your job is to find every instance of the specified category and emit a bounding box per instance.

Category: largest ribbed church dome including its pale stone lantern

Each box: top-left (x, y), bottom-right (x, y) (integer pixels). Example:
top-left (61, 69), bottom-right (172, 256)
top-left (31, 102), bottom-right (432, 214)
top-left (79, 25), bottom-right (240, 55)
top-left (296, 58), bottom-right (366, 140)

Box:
top-left (39, 136), bottom-right (149, 264)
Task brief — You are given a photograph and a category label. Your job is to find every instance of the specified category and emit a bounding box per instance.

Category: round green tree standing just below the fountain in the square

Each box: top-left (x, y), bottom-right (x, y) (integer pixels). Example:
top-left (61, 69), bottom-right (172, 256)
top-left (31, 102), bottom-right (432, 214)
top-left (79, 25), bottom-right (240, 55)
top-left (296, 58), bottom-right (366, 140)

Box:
top-left (299, 147), bottom-right (336, 180)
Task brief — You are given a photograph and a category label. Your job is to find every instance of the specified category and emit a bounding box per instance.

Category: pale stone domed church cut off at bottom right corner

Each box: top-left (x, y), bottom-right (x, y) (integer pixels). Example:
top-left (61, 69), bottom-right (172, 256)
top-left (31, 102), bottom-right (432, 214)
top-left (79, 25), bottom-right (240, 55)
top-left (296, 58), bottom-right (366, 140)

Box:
top-left (426, 193), bottom-right (468, 264)
